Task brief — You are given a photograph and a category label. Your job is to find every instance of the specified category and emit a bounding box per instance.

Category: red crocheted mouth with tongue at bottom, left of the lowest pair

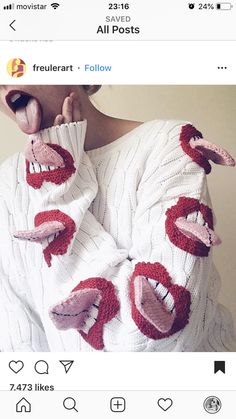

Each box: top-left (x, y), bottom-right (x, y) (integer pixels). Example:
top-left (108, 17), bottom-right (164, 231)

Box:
top-left (49, 278), bottom-right (120, 350)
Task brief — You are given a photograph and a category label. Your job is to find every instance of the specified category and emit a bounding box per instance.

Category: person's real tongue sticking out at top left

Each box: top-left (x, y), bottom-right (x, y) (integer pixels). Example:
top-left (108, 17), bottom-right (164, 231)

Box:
top-left (16, 97), bottom-right (42, 134)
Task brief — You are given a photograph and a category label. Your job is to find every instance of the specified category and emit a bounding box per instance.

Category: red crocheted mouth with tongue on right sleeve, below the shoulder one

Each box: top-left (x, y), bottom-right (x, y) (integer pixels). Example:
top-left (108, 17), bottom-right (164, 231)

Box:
top-left (165, 197), bottom-right (221, 256)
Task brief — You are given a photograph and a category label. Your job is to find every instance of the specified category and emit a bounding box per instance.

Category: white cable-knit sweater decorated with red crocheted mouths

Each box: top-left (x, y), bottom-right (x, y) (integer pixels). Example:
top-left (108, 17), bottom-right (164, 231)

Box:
top-left (0, 120), bottom-right (236, 351)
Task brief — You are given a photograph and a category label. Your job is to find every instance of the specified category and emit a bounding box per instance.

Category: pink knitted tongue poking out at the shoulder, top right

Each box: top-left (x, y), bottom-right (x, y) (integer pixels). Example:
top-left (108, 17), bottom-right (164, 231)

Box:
top-left (189, 138), bottom-right (235, 166)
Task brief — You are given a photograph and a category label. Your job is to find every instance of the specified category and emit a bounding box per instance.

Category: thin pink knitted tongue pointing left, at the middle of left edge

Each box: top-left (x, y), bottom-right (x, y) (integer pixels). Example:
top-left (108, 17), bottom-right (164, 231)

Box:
top-left (13, 221), bottom-right (65, 243)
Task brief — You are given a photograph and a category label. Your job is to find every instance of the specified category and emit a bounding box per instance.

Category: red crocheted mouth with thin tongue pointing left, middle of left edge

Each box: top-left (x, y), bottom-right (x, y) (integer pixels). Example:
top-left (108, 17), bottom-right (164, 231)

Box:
top-left (13, 210), bottom-right (76, 267)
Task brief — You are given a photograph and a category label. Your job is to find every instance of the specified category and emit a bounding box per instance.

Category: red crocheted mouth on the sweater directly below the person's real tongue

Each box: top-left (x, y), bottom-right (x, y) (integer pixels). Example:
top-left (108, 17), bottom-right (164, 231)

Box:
top-left (25, 136), bottom-right (76, 189)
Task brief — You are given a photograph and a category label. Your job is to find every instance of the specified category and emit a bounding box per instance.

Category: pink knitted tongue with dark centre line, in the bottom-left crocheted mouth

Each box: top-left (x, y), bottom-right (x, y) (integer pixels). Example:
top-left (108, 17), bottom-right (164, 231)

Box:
top-left (49, 288), bottom-right (100, 330)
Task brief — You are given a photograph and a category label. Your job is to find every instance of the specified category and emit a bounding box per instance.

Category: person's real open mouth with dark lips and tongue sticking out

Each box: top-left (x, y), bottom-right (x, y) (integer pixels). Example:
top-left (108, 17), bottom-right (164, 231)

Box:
top-left (5, 90), bottom-right (42, 134)
